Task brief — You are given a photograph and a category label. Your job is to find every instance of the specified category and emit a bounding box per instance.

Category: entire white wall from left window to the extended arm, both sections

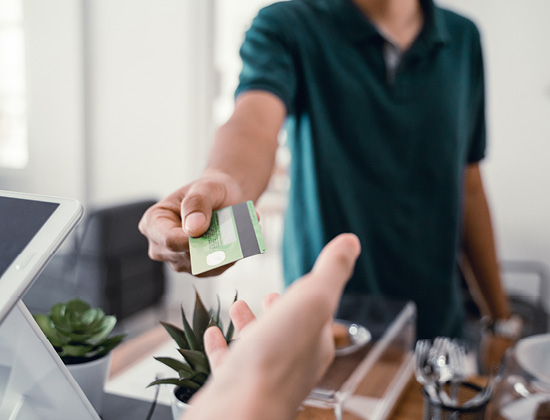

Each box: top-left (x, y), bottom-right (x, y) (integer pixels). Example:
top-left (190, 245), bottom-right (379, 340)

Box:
top-left (4, 0), bottom-right (215, 206)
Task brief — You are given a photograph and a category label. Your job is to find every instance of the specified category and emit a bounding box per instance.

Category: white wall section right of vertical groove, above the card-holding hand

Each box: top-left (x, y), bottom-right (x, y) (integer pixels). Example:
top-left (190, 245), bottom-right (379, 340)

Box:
top-left (87, 0), bottom-right (217, 203)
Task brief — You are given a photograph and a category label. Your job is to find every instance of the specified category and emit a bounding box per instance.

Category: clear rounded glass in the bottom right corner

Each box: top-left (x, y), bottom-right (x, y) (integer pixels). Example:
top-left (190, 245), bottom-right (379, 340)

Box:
top-left (487, 334), bottom-right (550, 420)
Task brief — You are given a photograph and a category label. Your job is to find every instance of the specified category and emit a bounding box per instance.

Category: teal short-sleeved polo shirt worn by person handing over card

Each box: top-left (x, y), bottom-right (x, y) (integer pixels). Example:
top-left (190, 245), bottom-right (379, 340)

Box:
top-left (236, 0), bottom-right (485, 337)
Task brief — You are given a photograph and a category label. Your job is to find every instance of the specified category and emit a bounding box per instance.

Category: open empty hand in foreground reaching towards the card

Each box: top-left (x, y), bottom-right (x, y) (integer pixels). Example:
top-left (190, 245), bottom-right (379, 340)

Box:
top-left (183, 234), bottom-right (360, 420)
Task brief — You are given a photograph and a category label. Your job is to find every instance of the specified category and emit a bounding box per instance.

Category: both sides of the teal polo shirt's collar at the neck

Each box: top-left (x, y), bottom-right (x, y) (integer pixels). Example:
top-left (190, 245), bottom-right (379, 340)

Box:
top-left (330, 0), bottom-right (450, 44)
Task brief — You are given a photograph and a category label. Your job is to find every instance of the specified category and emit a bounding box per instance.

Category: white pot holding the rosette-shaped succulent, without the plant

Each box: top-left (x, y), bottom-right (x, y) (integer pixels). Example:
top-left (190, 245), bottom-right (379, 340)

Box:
top-left (65, 353), bottom-right (111, 414)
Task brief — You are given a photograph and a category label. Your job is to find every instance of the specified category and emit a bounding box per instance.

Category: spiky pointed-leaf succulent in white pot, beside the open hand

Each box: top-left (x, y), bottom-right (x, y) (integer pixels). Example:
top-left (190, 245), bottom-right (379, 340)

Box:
top-left (148, 291), bottom-right (237, 420)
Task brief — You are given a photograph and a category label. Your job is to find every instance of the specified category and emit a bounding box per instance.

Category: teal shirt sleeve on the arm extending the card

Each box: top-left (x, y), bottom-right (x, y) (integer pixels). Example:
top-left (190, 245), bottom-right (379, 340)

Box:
top-left (235, 2), bottom-right (296, 113)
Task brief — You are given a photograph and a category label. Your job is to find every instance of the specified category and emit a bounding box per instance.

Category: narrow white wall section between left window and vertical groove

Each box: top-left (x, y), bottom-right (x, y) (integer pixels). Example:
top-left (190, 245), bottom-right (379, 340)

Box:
top-left (2, 0), bottom-right (84, 199)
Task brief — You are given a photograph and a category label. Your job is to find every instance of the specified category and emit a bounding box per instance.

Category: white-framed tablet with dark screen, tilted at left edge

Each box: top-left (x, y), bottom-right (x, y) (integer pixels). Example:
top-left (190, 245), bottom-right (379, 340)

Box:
top-left (0, 190), bottom-right (83, 323)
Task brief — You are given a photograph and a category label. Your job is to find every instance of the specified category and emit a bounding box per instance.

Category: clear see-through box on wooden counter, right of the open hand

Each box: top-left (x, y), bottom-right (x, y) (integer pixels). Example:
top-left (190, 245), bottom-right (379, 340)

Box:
top-left (298, 296), bottom-right (416, 420)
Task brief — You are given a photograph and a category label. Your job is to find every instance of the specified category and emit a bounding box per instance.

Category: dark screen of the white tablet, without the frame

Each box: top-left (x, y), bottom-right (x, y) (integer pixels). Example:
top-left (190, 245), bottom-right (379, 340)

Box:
top-left (0, 197), bottom-right (59, 281)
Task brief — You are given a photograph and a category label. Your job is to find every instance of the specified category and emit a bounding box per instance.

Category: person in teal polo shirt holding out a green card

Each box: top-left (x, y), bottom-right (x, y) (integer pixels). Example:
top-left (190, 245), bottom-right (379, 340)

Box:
top-left (140, 0), bottom-right (510, 354)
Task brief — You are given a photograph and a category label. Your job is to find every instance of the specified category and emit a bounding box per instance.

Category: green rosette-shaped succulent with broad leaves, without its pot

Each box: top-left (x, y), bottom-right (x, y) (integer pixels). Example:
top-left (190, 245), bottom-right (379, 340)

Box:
top-left (33, 299), bottom-right (126, 364)
